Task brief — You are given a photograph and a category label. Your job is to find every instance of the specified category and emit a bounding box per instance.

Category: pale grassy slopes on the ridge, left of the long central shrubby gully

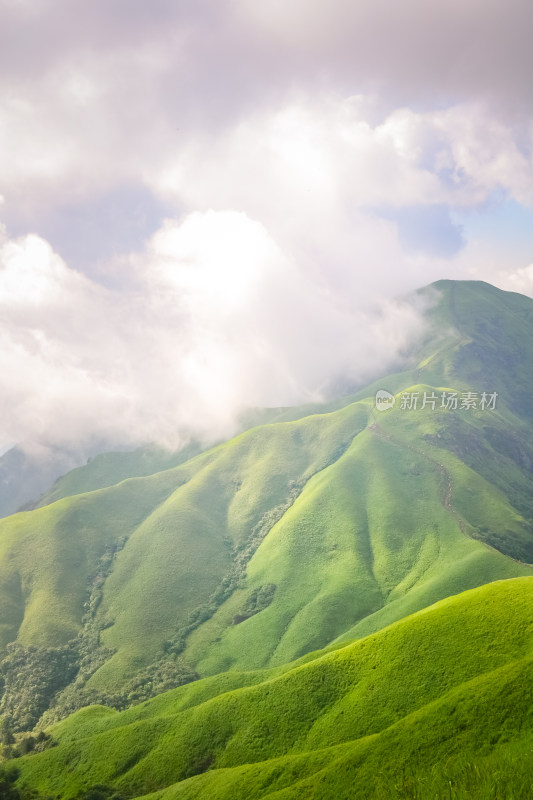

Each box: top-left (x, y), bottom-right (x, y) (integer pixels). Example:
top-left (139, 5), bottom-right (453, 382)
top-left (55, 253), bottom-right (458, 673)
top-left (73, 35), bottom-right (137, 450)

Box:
top-left (0, 405), bottom-right (368, 688)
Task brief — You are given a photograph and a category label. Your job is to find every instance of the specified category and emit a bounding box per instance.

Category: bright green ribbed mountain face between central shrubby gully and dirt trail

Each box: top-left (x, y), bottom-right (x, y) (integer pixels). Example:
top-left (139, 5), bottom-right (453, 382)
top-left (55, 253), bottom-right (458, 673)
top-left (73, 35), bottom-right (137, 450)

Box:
top-left (182, 404), bottom-right (531, 674)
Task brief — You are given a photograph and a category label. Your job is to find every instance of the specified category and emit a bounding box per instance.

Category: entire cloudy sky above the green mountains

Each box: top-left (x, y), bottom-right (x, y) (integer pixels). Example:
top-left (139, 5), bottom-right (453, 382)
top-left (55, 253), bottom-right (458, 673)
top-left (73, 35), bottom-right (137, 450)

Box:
top-left (0, 0), bottom-right (533, 451)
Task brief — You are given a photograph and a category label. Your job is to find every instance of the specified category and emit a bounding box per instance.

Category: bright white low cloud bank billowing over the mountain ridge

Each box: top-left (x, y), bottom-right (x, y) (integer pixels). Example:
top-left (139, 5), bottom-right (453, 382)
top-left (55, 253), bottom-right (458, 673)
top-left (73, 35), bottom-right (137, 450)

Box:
top-left (0, 216), bottom-right (421, 449)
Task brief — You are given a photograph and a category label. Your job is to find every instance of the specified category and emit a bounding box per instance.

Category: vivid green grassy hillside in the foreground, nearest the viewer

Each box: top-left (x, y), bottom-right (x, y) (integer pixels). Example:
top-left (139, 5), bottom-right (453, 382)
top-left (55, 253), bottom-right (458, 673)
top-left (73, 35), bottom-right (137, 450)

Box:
top-left (14, 578), bottom-right (533, 800)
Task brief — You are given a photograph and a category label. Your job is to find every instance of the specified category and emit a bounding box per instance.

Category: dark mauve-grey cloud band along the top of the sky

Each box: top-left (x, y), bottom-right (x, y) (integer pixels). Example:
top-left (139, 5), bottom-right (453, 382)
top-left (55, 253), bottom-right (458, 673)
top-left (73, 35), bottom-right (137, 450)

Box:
top-left (0, 0), bottom-right (533, 119)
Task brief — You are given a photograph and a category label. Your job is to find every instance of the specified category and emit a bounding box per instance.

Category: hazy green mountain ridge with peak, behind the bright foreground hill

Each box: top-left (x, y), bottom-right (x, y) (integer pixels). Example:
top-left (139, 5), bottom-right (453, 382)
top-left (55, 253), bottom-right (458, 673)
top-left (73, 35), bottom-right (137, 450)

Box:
top-left (0, 282), bottom-right (533, 727)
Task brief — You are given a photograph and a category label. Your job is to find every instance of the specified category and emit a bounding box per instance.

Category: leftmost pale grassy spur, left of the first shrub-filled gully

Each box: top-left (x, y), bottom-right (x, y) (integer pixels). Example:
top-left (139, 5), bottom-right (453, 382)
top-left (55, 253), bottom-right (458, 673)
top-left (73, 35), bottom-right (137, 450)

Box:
top-left (0, 476), bottom-right (185, 647)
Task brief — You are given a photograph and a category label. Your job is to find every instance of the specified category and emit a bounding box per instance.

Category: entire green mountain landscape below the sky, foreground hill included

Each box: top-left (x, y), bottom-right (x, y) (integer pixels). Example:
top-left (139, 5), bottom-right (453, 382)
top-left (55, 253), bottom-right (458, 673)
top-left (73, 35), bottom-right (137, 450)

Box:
top-left (0, 280), bottom-right (533, 800)
